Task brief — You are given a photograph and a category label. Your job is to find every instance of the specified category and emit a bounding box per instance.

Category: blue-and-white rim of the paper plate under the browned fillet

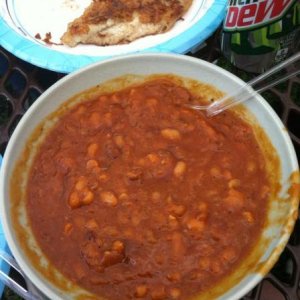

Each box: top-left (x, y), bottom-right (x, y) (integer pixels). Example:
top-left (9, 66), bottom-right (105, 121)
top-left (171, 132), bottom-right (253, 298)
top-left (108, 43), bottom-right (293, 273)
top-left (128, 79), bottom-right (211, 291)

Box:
top-left (0, 0), bottom-right (227, 73)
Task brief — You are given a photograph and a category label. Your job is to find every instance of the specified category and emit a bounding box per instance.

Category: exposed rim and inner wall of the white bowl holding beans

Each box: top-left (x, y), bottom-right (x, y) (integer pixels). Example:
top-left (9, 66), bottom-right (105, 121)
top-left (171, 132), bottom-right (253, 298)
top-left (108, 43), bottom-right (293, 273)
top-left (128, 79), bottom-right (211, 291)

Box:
top-left (0, 54), bottom-right (299, 300)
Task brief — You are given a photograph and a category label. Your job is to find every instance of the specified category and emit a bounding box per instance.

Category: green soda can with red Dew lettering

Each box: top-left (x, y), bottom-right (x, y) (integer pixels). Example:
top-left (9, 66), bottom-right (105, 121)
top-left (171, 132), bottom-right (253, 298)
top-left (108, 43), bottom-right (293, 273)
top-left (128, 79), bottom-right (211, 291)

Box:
top-left (221, 0), bottom-right (300, 73)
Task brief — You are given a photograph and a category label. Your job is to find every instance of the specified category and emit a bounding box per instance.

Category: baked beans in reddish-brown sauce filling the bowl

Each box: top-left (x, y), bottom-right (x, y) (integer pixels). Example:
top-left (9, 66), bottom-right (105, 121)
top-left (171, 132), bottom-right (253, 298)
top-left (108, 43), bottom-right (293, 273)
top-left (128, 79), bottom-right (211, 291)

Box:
top-left (27, 79), bottom-right (269, 299)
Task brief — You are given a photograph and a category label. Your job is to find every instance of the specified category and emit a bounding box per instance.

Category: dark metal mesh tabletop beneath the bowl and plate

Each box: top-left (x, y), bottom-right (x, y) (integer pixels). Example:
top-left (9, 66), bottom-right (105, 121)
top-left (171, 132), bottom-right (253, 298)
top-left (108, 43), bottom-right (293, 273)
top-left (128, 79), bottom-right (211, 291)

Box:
top-left (0, 32), bottom-right (300, 300)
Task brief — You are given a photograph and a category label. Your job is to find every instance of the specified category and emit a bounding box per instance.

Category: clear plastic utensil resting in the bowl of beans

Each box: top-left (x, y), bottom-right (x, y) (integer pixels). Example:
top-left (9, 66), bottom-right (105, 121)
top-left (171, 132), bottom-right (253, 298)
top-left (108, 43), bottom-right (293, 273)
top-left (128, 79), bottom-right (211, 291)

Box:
top-left (188, 52), bottom-right (300, 116)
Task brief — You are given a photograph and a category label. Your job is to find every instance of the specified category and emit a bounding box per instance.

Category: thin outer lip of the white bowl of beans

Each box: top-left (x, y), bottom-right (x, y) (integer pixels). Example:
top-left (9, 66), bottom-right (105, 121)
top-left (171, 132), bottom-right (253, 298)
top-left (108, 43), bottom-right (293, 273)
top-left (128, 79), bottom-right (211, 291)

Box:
top-left (0, 53), bottom-right (300, 299)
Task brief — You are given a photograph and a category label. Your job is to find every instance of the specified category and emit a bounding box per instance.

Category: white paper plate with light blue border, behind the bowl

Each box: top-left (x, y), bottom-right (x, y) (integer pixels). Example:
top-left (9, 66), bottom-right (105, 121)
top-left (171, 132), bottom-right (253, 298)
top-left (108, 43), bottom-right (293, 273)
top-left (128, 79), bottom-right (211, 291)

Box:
top-left (0, 0), bottom-right (227, 73)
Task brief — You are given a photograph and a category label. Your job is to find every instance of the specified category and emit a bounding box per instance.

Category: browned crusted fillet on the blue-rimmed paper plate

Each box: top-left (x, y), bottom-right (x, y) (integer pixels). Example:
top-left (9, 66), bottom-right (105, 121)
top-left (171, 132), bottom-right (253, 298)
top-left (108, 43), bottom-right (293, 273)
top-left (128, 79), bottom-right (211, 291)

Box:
top-left (61, 0), bottom-right (193, 47)
